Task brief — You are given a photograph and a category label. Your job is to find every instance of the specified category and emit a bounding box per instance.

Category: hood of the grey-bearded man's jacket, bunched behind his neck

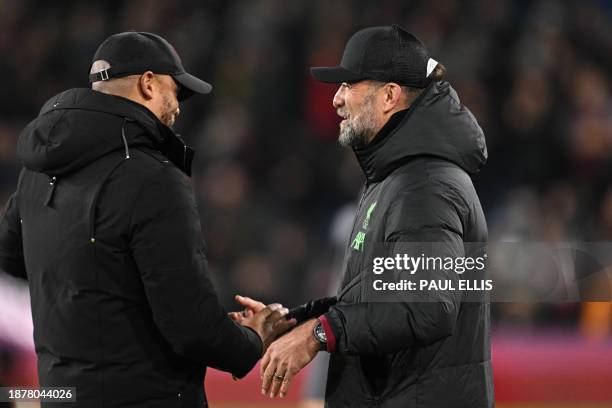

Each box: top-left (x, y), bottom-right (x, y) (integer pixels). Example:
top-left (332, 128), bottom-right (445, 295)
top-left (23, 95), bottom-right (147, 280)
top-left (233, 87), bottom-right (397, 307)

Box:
top-left (354, 81), bottom-right (487, 182)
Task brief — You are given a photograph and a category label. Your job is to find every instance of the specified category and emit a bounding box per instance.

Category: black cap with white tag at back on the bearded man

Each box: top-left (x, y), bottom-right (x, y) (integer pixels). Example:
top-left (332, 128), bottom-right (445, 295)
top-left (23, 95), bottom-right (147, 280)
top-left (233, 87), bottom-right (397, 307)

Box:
top-left (310, 24), bottom-right (438, 88)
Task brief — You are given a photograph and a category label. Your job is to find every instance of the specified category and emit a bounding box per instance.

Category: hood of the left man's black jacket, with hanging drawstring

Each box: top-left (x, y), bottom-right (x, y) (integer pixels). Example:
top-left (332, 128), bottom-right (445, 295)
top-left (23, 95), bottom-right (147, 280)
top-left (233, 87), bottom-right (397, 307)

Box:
top-left (17, 88), bottom-right (193, 176)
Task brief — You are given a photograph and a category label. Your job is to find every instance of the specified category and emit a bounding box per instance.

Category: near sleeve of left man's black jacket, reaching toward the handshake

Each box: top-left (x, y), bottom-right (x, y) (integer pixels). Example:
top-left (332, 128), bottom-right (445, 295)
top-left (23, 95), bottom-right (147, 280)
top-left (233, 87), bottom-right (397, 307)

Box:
top-left (130, 166), bottom-right (262, 377)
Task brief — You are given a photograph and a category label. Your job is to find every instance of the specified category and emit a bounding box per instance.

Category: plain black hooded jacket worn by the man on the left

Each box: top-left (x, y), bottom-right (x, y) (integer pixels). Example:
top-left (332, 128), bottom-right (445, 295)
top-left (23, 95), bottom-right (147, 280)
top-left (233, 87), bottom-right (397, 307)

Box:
top-left (0, 89), bottom-right (262, 408)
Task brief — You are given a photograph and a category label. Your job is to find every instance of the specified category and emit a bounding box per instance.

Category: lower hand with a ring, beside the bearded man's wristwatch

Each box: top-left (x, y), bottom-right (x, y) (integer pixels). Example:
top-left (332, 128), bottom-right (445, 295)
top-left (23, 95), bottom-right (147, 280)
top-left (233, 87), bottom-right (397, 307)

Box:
top-left (261, 319), bottom-right (321, 398)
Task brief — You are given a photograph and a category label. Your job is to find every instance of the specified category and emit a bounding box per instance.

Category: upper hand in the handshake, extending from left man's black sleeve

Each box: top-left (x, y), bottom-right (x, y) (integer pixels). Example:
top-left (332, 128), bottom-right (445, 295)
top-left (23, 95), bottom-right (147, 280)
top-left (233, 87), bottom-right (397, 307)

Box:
top-left (239, 303), bottom-right (297, 353)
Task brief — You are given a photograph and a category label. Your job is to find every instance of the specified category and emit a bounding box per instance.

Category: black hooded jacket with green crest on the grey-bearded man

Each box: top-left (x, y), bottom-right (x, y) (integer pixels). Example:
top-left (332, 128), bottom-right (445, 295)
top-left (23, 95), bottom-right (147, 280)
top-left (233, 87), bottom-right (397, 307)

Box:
top-left (292, 82), bottom-right (494, 408)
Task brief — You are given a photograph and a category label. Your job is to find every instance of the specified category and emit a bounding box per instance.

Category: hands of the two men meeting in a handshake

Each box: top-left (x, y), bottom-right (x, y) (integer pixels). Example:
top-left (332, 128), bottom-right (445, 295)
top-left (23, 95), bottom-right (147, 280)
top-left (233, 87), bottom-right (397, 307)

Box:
top-left (229, 296), bottom-right (324, 398)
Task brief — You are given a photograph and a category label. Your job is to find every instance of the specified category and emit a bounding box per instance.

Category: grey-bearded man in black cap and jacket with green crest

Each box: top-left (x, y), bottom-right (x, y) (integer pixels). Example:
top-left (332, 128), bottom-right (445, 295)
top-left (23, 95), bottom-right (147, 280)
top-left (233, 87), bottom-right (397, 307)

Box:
top-left (241, 25), bottom-right (494, 408)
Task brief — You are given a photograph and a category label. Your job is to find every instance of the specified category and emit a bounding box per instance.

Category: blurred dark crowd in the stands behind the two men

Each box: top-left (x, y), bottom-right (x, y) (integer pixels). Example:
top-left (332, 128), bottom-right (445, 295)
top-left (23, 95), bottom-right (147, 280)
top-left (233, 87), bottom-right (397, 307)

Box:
top-left (0, 0), bottom-right (612, 404)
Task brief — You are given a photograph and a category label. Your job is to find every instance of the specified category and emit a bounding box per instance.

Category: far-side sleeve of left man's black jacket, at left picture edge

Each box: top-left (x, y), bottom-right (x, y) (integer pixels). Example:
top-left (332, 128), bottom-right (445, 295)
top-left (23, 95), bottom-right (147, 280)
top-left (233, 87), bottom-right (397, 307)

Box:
top-left (0, 193), bottom-right (27, 279)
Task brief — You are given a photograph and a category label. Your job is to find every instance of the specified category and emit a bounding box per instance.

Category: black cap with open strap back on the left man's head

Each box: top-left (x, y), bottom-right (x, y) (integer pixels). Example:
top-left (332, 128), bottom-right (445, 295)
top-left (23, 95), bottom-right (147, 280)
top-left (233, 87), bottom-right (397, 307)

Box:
top-left (89, 31), bottom-right (212, 101)
